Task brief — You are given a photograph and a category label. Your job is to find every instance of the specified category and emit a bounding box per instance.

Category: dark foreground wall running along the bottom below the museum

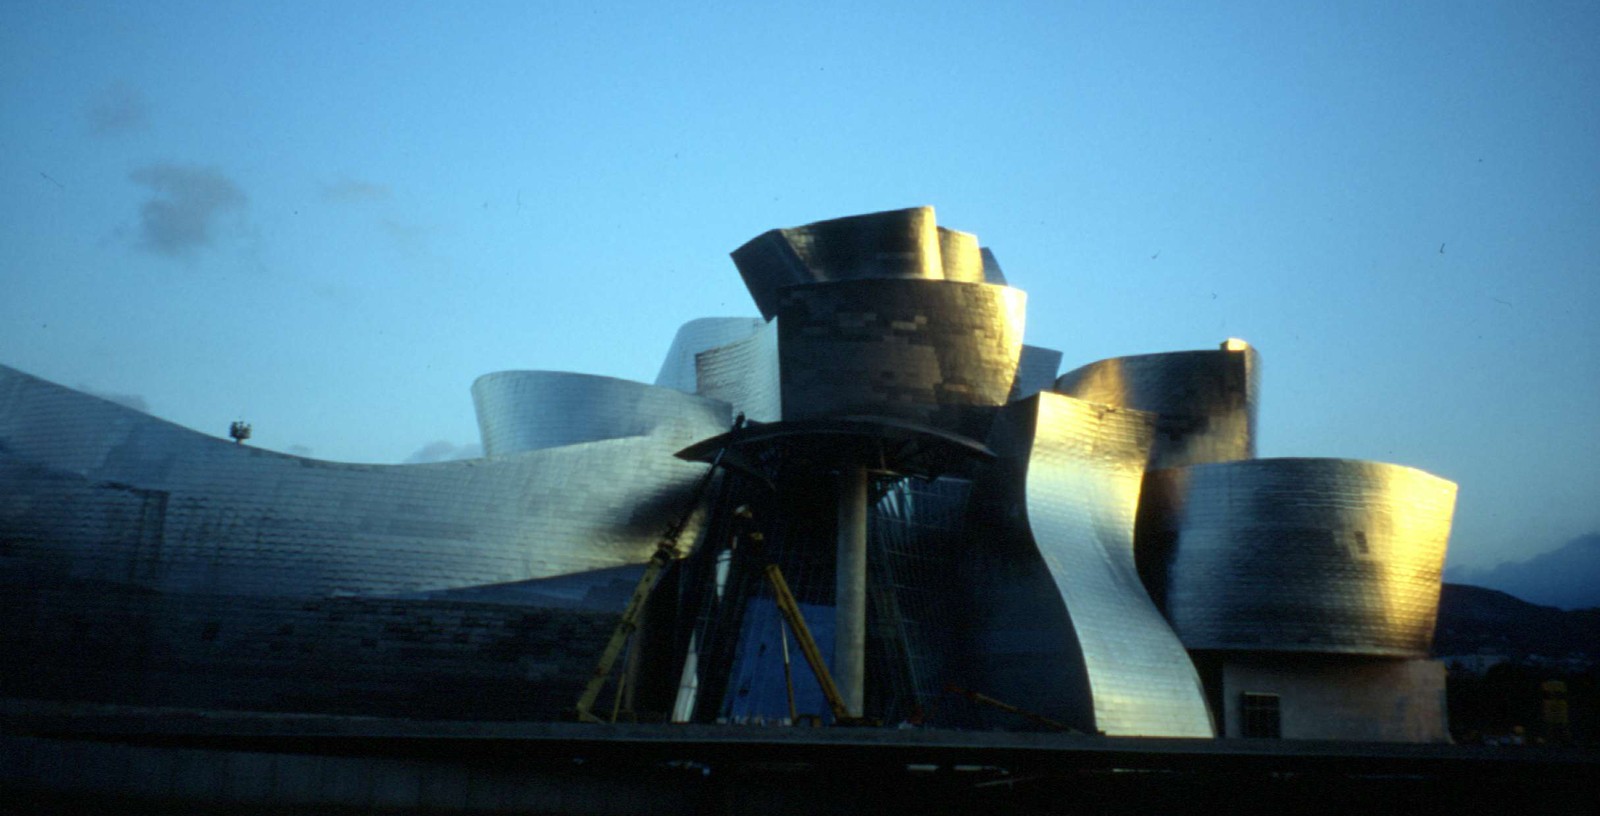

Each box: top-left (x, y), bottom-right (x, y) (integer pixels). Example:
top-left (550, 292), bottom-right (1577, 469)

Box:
top-left (0, 706), bottom-right (1600, 816)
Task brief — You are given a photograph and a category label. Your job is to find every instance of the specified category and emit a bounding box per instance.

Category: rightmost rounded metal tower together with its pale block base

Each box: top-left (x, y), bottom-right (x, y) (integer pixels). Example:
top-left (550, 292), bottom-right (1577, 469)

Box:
top-left (1138, 459), bottom-right (1456, 742)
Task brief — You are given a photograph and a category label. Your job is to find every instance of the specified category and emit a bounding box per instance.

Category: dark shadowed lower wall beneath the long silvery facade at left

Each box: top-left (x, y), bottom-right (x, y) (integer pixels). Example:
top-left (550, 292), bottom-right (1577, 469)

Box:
top-left (0, 581), bottom-right (618, 720)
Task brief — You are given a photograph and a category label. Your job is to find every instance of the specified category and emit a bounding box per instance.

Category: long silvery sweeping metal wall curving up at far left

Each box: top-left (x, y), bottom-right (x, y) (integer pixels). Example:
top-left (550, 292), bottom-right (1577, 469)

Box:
top-left (0, 368), bottom-right (716, 595)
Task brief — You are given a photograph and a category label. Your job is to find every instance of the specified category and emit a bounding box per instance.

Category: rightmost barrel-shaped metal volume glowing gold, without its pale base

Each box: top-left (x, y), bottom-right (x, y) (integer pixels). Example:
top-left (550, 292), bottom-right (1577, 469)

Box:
top-left (1139, 459), bottom-right (1456, 658)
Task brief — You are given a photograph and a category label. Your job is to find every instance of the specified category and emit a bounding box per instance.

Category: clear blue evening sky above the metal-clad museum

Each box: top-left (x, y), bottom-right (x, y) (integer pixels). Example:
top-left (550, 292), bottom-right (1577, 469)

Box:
top-left (0, 2), bottom-right (1600, 566)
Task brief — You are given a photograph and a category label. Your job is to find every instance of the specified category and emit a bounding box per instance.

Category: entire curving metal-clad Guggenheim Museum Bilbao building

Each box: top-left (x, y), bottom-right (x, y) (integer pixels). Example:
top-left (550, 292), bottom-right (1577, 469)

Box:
top-left (0, 208), bottom-right (1456, 742)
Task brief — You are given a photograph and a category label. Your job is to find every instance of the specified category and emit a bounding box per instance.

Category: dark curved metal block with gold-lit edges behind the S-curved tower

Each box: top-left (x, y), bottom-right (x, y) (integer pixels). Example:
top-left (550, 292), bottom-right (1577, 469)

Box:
top-left (1056, 339), bottom-right (1261, 470)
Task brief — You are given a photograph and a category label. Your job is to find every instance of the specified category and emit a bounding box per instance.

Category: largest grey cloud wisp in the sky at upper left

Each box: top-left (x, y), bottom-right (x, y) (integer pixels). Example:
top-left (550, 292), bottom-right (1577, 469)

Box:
top-left (128, 165), bottom-right (245, 256)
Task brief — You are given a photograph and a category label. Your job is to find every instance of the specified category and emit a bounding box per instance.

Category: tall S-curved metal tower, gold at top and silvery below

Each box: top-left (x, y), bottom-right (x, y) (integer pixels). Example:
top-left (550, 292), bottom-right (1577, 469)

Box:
top-left (992, 392), bottom-right (1213, 738)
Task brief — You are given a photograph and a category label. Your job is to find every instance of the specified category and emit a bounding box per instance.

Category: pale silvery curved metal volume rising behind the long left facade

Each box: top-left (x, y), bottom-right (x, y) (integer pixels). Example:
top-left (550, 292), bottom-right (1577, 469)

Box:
top-left (472, 371), bottom-right (731, 458)
